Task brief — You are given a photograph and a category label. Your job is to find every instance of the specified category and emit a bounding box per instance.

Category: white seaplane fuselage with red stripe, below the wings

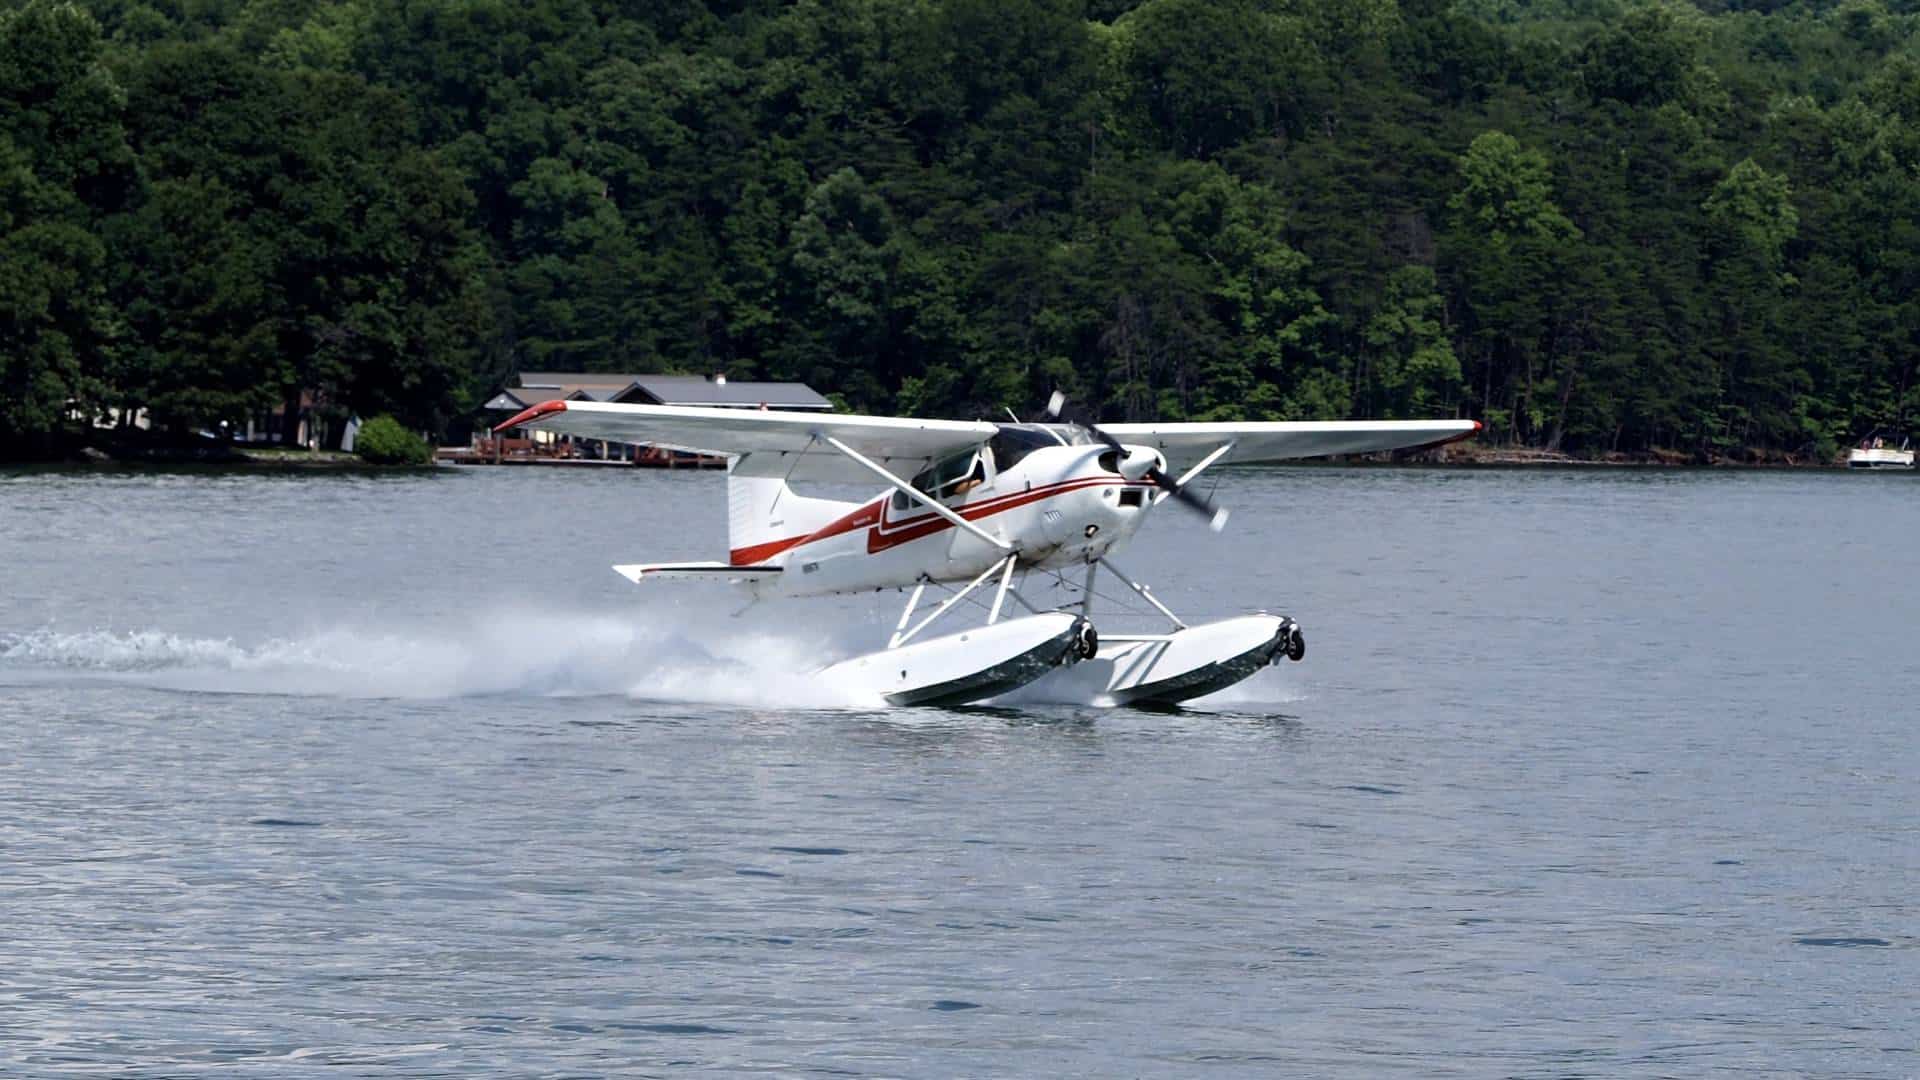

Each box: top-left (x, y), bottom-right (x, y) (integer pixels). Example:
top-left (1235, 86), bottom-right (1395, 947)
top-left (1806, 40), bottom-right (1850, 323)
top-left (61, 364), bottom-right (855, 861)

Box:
top-left (730, 444), bottom-right (1162, 598)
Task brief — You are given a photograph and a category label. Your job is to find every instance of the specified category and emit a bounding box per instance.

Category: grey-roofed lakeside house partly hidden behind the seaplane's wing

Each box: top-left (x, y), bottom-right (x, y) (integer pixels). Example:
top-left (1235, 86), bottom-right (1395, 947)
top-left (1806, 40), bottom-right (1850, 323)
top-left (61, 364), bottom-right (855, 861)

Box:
top-left (464, 371), bottom-right (833, 467)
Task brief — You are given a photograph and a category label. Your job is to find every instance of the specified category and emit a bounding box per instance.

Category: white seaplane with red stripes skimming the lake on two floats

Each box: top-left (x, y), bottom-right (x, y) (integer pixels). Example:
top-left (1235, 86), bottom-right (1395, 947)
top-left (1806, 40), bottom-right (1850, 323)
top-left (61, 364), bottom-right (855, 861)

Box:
top-left (495, 394), bottom-right (1480, 705)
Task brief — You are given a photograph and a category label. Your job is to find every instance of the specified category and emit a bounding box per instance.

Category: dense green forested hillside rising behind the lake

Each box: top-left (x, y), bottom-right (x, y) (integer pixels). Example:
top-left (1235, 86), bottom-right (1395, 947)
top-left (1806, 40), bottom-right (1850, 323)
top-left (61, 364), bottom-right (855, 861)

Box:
top-left (0, 0), bottom-right (1920, 457)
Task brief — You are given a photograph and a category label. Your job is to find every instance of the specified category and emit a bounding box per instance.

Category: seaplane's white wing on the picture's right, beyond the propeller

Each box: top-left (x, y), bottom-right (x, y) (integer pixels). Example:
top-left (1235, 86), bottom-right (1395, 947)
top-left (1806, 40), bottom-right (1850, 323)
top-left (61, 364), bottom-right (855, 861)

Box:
top-left (1100, 421), bottom-right (1480, 471)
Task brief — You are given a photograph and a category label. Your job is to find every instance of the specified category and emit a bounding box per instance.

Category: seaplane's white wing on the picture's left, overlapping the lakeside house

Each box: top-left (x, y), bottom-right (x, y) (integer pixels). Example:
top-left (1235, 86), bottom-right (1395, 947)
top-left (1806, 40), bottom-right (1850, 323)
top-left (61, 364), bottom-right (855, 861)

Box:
top-left (495, 402), bottom-right (998, 482)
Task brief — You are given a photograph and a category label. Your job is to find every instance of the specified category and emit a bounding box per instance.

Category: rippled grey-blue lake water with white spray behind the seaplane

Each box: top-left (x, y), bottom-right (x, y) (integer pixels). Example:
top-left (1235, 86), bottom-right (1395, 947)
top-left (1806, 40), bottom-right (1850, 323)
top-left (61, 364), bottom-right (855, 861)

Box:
top-left (0, 467), bottom-right (1920, 1076)
